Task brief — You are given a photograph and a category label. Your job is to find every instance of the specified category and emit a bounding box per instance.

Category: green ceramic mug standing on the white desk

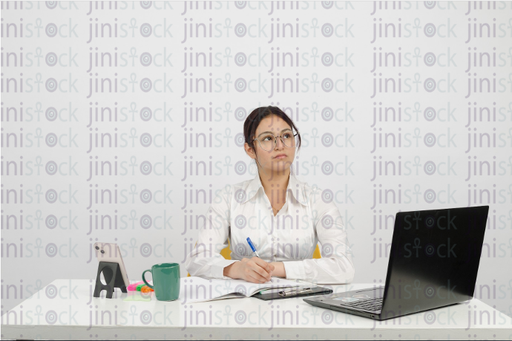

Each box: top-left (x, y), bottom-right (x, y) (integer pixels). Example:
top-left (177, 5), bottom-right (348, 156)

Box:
top-left (142, 263), bottom-right (180, 301)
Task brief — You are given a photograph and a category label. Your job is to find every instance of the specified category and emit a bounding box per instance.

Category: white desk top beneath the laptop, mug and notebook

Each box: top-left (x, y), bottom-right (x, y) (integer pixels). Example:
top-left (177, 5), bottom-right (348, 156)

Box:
top-left (1, 279), bottom-right (512, 340)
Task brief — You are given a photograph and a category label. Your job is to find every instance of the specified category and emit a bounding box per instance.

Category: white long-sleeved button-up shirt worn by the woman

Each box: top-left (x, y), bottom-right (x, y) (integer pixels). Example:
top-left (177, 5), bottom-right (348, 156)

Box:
top-left (185, 171), bottom-right (355, 284)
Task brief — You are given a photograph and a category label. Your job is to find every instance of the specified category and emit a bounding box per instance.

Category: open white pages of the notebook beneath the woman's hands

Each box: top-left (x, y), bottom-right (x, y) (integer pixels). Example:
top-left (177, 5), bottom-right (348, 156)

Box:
top-left (178, 277), bottom-right (307, 304)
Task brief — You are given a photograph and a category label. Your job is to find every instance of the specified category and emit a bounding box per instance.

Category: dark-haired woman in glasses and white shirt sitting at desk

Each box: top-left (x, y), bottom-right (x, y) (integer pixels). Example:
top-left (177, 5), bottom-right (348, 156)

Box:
top-left (185, 106), bottom-right (354, 283)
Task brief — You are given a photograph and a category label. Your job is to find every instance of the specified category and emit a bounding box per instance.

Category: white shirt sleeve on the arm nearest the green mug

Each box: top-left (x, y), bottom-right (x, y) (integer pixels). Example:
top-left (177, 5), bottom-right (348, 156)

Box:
top-left (185, 185), bottom-right (236, 279)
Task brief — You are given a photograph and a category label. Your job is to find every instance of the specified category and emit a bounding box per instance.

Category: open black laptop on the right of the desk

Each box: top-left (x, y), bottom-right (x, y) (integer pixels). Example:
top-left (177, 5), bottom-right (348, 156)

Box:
top-left (304, 206), bottom-right (489, 320)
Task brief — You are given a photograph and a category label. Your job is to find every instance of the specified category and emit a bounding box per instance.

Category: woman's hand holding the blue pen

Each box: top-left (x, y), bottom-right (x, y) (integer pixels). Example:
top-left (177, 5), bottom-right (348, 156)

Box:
top-left (224, 257), bottom-right (275, 283)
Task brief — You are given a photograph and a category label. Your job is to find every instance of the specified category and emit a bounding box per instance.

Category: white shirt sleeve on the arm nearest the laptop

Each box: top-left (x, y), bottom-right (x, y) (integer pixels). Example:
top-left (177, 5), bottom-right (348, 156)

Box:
top-left (283, 196), bottom-right (355, 284)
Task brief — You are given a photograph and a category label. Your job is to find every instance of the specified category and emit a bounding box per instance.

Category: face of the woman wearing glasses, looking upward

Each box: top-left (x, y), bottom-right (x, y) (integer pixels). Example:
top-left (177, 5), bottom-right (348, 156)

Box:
top-left (245, 115), bottom-right (295, 175)
